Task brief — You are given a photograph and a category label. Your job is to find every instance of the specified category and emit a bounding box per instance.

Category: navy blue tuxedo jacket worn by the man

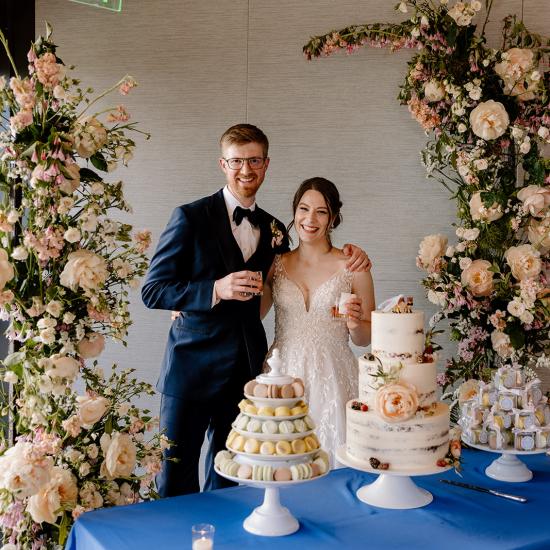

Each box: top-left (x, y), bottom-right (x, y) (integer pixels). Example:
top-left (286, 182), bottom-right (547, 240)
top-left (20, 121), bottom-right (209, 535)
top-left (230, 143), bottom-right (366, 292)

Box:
top-left (141, 190), bottom-right (288, 400)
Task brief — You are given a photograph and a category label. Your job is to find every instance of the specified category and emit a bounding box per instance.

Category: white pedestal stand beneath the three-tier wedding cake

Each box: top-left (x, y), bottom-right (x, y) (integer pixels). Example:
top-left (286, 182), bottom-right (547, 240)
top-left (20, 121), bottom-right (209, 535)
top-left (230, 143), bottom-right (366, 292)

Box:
top-left (336, 445), bottom-right (451, 510)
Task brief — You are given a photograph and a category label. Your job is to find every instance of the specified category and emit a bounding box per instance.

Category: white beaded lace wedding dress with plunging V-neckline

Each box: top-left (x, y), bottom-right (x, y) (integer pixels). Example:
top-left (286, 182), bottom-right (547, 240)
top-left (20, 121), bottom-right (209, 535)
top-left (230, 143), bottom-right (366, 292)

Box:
top-left (271, 256), bottom-right (358, 467)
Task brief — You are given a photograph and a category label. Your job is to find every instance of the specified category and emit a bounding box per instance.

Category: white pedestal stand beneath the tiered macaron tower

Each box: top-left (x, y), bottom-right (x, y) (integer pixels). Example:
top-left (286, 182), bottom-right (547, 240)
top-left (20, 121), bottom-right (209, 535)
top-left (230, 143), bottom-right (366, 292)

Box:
top-left (215, 468), bottom-right (328, 537)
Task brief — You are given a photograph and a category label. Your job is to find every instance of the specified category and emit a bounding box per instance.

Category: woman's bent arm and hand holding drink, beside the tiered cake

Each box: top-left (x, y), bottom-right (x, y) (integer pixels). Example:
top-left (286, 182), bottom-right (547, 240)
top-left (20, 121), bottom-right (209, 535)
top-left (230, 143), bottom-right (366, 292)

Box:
top-left (347, 271), bottom-right (376, 346)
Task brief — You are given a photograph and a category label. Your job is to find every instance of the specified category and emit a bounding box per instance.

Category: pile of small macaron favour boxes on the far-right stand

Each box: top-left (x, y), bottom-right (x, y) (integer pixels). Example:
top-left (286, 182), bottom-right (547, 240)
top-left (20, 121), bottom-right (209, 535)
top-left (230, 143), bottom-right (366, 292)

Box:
top-left (459, 366), bottom-right (550, 451)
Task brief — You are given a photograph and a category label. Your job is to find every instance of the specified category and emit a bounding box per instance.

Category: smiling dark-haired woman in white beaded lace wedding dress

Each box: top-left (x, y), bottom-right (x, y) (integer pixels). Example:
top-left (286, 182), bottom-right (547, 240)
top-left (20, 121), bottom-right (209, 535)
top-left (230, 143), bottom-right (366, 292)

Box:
top-left (262, 177), bottom-right (375, 464)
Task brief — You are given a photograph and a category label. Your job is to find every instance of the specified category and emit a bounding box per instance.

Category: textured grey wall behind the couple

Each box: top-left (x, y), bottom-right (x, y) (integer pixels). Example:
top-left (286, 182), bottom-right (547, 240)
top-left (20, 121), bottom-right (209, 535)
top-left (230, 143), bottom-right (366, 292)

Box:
top-left (36, 0), bottom-right (550, 410)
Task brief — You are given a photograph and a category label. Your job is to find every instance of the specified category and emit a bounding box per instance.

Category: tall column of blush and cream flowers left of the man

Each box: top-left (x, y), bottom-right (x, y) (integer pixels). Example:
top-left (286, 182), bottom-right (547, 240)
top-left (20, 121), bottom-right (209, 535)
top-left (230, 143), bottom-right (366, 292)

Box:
top-left (0, 28), bottom-right (169, 550)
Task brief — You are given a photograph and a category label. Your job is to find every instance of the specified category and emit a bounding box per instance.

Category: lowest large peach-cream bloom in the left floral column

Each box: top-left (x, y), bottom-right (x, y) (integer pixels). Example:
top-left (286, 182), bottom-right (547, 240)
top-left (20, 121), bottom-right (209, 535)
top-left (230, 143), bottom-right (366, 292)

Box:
top-left (27, 466), bottom-right (78, 523)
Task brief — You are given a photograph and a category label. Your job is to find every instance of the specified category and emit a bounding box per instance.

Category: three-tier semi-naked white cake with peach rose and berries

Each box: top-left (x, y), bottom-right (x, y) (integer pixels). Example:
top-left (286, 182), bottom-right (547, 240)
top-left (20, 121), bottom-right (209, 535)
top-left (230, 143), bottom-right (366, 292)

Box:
top-left (346, 297), bottom-right (452, 470)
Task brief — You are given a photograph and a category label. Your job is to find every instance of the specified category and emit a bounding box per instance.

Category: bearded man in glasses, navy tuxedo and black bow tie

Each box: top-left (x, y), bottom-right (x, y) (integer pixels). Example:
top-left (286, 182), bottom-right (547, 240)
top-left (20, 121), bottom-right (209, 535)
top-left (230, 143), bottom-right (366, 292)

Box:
top-left (142, 124), bottom-right (368, 497)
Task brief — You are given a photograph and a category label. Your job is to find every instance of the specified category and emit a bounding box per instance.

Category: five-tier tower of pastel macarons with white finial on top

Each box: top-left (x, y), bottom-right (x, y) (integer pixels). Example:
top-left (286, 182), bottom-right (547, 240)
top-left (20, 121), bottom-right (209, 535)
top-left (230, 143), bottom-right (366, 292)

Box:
top-left (214, 349), bottom-right (329, 482)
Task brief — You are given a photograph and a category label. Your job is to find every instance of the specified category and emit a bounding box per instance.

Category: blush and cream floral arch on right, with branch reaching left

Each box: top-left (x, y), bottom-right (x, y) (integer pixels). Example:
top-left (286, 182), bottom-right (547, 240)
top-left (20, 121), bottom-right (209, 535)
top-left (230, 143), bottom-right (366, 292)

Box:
top-left (304, 0), bottom-right (550, 396)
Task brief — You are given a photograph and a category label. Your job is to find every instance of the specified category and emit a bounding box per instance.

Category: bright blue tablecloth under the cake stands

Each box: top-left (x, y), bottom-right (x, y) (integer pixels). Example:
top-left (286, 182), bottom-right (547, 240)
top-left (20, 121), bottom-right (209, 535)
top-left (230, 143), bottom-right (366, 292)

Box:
top-left (66, 451), bottom-right (550, 550)
